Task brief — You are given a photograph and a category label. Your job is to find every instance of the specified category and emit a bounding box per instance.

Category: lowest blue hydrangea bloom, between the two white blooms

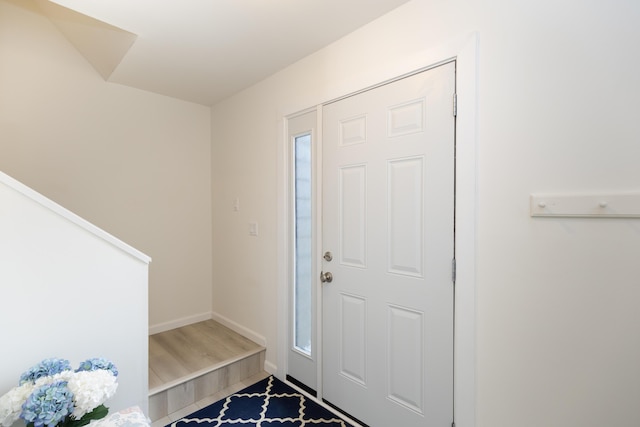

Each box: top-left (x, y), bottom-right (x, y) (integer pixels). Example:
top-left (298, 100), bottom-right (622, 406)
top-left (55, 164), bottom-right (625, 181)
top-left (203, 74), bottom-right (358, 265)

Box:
top-left (20, 381), bottom-right (73, 427)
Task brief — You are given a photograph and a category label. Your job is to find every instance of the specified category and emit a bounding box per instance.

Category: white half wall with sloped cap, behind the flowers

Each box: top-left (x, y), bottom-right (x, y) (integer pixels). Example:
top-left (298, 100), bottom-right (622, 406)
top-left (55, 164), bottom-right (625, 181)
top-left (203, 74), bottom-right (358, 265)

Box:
top-left (0, 172), bottom-right (150, 413)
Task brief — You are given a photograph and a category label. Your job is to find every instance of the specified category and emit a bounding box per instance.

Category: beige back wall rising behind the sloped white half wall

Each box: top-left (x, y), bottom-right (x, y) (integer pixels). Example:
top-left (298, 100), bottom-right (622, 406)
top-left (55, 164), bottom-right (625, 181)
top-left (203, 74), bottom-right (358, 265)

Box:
top-left (0, 1), bottom-right (211, 326)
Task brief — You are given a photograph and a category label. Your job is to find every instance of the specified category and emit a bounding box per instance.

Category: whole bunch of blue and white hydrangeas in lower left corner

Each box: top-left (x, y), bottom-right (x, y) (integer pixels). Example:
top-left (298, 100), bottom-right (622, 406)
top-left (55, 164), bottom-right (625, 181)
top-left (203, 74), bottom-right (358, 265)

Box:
top-left (0, 358), bottom-right (118, 427)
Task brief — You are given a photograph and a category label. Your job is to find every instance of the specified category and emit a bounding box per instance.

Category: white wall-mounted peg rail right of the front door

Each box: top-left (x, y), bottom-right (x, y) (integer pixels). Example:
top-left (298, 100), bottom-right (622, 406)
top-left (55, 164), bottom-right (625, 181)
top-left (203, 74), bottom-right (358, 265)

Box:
top-left (530, 193), bottom-right (640, 218)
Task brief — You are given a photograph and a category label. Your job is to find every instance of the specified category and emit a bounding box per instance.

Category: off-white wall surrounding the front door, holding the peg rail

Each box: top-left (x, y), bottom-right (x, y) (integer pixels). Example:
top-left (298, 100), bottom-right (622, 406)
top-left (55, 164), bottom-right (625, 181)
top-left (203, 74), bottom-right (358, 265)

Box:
top-left (212, 0), bottom-right (640, 427)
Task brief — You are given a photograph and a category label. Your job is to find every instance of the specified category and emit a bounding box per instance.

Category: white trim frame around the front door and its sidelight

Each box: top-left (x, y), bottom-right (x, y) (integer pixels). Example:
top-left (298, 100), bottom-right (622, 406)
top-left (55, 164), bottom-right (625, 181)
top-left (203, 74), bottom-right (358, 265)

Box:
top-left (278, 33), bottom-right (478, 427)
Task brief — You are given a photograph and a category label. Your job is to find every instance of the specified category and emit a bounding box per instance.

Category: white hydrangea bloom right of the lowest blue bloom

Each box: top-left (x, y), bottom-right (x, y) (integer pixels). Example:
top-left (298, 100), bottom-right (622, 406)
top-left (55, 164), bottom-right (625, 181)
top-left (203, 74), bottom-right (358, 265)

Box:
top-left (67, 369), bottom-right (118, 419)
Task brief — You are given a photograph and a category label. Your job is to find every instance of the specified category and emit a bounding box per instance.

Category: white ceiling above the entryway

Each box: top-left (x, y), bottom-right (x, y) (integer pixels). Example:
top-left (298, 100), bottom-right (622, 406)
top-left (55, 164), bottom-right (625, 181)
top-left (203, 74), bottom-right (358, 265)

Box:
top-left (41, 0), bottom-right (408, 105)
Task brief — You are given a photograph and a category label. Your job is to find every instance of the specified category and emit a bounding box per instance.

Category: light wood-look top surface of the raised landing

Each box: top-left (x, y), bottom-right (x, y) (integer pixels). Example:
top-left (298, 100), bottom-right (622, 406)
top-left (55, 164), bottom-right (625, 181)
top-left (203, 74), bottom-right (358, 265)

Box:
top-left (149, 320), bottom-right (263, 395)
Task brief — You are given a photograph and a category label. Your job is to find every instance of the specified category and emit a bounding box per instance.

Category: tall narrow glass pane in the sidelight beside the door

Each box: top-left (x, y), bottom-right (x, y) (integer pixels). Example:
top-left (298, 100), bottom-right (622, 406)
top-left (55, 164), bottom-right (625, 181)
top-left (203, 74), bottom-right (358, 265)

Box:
top-left (294, 135), bottom-right (312, 355)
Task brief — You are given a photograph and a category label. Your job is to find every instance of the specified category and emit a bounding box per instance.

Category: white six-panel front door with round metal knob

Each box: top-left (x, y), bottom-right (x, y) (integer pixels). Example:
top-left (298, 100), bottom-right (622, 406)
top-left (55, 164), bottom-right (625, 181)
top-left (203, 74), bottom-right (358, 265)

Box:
top-left (322, 62), bottom-right (455, 427)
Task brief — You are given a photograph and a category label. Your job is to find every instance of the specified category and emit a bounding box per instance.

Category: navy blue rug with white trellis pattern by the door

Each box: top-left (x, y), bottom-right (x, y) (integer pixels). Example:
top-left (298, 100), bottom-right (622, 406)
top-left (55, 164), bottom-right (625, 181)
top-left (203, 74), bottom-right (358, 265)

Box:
top-left (167, 376), bottom-right (352, 427)
